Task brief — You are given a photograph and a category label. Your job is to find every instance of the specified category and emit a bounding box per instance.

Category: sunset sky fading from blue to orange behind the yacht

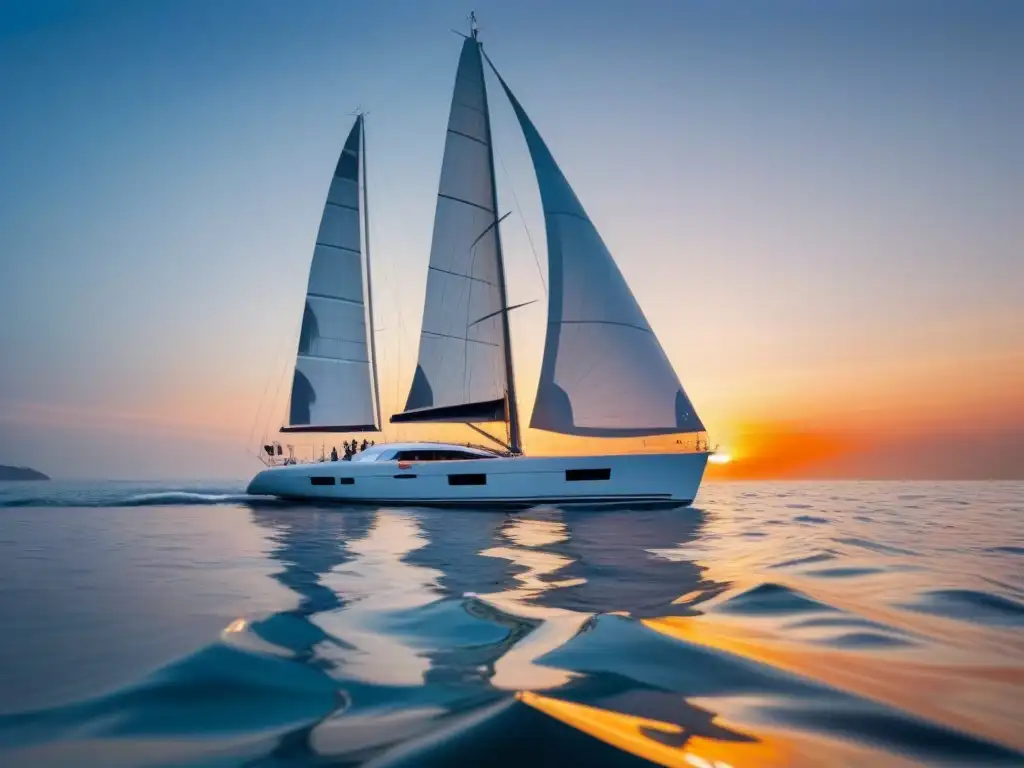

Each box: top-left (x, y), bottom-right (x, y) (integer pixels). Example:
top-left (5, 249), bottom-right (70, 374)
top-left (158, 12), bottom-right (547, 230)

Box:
top-left (0, 0), bottom-right (1024, 478)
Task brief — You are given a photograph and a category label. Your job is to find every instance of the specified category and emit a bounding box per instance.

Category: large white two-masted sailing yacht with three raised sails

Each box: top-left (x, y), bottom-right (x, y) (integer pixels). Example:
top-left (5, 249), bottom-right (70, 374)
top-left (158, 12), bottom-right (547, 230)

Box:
top-left (248, 18), bottom-right (709, 507)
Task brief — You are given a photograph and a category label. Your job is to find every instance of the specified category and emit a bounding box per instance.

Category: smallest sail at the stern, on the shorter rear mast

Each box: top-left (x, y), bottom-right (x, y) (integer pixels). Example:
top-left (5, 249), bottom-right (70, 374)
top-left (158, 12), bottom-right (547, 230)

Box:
top-left (282, 116), bottom-right (378, 432)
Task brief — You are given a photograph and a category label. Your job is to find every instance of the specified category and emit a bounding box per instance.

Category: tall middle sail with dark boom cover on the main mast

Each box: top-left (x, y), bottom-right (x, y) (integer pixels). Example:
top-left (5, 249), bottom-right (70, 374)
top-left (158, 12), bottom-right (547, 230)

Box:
top-left (392, 38), bottom-right (506, 422)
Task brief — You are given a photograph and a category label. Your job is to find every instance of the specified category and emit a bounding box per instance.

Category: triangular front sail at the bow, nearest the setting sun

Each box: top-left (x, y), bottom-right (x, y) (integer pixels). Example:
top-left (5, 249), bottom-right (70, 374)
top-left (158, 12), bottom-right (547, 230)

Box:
top-left (495, 71), bottom-right (703, 437)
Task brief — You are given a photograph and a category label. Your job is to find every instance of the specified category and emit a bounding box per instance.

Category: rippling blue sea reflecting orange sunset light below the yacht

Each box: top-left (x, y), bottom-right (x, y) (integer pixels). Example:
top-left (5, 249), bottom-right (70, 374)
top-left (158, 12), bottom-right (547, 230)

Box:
top-left (0, 482), bottom-right (1024, 768)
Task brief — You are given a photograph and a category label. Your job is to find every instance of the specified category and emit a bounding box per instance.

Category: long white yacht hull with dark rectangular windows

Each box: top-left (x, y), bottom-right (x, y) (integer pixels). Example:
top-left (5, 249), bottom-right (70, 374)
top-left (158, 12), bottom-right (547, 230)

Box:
top-left (248, 453), bottom-right (708, 507)
